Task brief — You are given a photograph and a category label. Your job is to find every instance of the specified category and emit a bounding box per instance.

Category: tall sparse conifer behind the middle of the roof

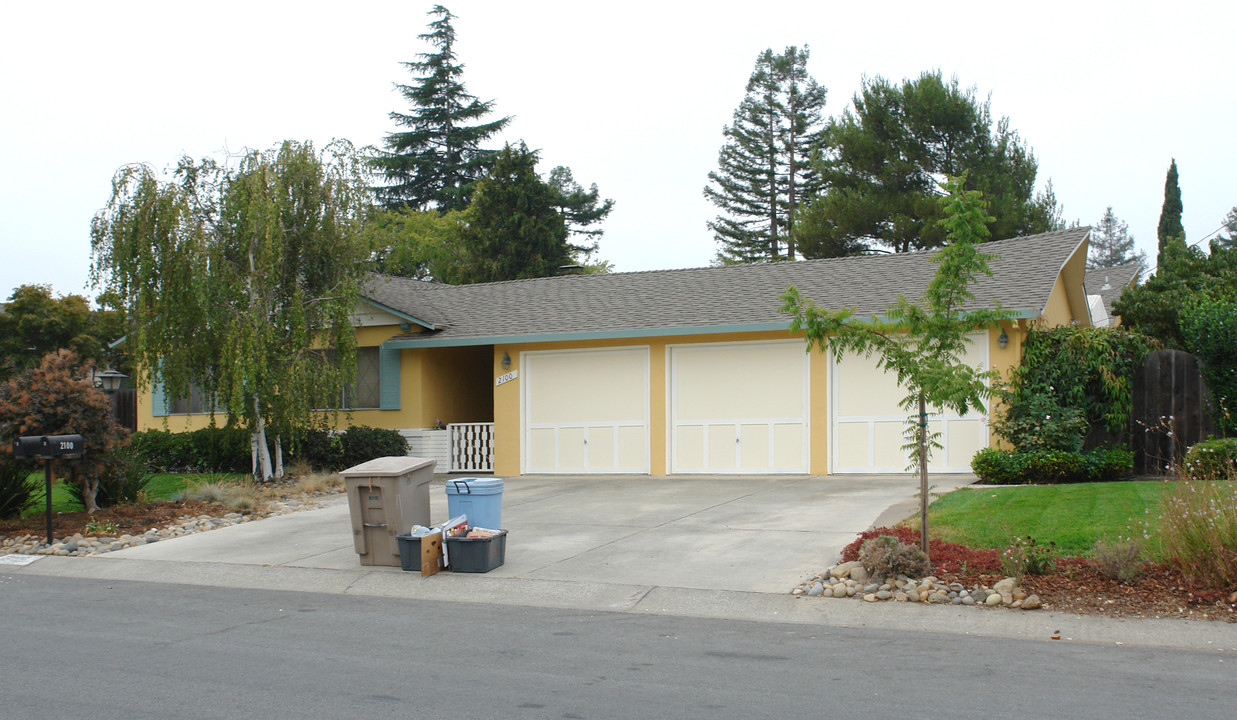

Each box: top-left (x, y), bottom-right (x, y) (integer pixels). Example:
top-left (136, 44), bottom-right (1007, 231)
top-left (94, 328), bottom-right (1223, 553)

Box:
top-left (704, 46), bottom-right (825, 262)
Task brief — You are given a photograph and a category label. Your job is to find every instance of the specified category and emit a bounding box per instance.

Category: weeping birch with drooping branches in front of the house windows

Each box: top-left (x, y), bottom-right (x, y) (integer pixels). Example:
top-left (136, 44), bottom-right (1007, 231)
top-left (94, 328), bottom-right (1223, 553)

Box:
top-left (90, 141), bottom-right (370, 480)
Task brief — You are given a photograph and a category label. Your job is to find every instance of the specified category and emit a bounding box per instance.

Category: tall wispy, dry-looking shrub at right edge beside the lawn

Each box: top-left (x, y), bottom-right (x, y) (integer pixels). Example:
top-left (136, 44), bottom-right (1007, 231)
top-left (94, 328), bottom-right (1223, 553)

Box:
top-left (1158, 471), bottom-right (1237, 590)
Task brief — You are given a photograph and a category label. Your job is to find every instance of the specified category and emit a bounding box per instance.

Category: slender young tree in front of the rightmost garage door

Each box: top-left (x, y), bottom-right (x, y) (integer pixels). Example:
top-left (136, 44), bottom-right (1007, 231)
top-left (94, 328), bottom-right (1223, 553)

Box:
top-left (782, 177), bottom-right (1011, 554)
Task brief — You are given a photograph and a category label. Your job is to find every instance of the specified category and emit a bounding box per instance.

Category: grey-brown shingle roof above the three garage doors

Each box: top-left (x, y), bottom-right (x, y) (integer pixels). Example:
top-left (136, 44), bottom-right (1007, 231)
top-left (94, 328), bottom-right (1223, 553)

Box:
top-left (365, 228), bottom-right (1090, 345)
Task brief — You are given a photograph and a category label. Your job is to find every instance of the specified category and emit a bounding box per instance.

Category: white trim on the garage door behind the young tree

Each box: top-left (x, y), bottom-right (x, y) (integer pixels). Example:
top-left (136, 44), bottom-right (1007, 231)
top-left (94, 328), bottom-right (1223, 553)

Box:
top-left (826, 330), bottom-right (992, 475)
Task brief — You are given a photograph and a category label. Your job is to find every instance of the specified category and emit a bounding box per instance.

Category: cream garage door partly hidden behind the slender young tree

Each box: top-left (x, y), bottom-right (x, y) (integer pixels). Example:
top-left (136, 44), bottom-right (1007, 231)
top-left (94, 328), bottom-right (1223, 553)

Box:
top-left (829, 335), bottom-right (988, 474)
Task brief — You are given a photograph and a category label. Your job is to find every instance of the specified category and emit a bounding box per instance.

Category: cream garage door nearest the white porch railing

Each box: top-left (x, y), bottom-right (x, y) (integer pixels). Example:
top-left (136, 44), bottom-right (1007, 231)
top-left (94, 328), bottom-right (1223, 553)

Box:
top-left (521, 348), bottom-right (648, 473)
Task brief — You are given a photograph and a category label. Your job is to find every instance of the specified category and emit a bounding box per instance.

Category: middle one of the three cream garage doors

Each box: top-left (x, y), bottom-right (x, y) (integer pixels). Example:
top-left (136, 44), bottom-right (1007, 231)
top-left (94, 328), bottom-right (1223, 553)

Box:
top-left (669, 341), bottom-right (808, 474)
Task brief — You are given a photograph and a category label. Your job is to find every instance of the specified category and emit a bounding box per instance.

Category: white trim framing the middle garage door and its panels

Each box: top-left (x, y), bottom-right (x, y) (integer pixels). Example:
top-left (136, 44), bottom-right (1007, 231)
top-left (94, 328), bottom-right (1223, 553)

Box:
top-left (666, 340), bottom-right (811, 475)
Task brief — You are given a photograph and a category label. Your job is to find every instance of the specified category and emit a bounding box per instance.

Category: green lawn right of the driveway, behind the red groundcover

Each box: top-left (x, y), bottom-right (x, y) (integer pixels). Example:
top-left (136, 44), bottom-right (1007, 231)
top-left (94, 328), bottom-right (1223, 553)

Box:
top-left (928, 481), bottom-right (1170, 555)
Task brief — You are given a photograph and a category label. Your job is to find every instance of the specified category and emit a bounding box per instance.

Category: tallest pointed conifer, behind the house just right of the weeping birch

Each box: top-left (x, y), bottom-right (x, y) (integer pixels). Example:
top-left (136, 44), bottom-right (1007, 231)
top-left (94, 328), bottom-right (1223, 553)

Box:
top-left (372, 5), bottom-right (511, 213)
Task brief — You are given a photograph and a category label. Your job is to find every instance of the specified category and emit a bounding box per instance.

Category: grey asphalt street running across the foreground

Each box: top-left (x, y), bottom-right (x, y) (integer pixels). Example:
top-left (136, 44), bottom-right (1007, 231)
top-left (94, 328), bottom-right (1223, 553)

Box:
top-left (0, 572), bottom-right (1237, 720)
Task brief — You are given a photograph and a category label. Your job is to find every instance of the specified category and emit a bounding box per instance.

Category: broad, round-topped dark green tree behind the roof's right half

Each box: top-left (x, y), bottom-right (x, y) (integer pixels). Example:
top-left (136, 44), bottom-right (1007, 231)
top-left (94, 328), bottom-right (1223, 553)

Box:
top-left (797, 72), bottom-right (1061, 257)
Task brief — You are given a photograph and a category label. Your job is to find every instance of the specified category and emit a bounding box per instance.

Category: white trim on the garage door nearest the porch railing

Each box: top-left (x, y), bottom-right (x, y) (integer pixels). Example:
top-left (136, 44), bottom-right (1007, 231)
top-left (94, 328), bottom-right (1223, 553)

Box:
top-left (520, 345), bottom-right (651, 474)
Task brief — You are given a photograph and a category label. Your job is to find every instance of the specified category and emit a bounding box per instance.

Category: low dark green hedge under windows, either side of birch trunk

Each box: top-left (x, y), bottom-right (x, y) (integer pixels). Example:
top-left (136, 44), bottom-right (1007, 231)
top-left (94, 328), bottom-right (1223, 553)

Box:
top-left (134, 426), bottom-right (408, 473)
